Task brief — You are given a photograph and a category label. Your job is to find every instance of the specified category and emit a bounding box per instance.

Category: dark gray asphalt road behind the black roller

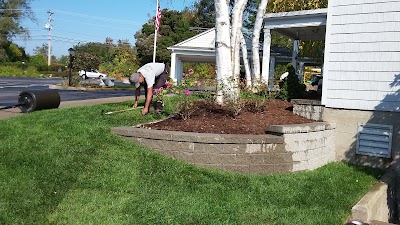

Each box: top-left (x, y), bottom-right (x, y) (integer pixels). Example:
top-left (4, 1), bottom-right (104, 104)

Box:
top-left (0, 77), bottom-right (134, 107)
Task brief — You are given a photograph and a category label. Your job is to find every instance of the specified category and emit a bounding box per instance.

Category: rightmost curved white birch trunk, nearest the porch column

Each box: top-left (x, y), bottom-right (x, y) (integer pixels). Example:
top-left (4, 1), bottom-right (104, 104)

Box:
top-left (252, 0), bottom-right (268, 85)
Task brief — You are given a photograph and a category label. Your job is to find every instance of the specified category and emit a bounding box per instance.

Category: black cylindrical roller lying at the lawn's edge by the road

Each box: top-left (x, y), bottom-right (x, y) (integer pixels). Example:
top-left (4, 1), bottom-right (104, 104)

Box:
top-left (18, 90), bottom-right (60, 113)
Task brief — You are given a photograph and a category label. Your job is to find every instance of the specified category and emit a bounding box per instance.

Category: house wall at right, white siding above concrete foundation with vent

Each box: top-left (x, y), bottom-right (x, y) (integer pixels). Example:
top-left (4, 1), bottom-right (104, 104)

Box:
top-left (322, 0), bottom-right (400, 165)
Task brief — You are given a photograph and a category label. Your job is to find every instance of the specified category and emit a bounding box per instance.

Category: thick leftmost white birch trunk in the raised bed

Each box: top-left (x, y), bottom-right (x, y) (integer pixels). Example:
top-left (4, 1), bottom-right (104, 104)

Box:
top-left (214, 0), bottom-right (233, 104)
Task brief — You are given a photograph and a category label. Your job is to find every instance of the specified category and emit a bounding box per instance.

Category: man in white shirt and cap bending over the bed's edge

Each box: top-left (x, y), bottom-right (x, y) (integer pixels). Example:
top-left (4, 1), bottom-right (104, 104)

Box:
top-left (129, 63), bottom-right (168, 115)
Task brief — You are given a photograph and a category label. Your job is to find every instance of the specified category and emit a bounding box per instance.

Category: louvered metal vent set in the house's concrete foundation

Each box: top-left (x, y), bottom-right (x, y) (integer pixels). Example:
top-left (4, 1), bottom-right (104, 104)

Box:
top-left (356, 123), bottom-right (393, 158)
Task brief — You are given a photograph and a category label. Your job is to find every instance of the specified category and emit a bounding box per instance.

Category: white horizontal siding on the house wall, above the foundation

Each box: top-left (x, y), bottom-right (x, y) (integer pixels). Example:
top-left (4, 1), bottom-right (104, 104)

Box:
top-left (322, 0), bottom-right (400, 111)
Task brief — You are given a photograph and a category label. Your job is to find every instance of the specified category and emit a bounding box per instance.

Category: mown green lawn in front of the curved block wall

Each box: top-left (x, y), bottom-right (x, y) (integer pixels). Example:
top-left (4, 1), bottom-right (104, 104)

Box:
top-left (0, 99), bottom-right (382, 225)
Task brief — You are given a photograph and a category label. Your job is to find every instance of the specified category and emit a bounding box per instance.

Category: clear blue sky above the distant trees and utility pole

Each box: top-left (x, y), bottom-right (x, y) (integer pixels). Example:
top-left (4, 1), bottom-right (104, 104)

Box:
top-left (13, 0), bottom-right (195, 57)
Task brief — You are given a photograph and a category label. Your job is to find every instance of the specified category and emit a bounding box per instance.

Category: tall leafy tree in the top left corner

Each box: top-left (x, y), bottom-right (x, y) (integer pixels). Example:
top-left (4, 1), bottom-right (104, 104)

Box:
top-left (0, 0), bottom-right (35, 62)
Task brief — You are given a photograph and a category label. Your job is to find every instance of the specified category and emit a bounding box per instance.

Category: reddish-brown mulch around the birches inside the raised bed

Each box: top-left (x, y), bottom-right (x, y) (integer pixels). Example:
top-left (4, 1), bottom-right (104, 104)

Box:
top-left (146, 100), bottom-right (315, 134)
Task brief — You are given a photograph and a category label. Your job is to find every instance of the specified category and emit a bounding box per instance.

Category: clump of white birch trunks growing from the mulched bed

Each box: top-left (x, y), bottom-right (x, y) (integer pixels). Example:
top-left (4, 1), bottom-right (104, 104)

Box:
top-left (214, 0), bottom-right (268, 103)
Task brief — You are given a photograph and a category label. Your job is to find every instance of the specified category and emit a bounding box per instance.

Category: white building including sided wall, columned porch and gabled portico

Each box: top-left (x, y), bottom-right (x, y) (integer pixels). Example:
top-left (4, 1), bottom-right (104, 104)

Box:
top-left (168, 0), bottom-right (400, 169)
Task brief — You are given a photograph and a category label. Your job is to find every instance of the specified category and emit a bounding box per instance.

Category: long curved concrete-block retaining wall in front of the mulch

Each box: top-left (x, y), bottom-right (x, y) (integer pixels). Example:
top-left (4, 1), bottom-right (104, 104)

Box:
top-left (112, 123), bottom-right (335, 174)
